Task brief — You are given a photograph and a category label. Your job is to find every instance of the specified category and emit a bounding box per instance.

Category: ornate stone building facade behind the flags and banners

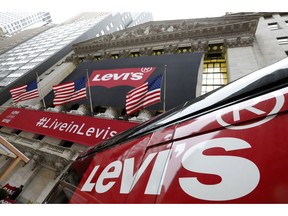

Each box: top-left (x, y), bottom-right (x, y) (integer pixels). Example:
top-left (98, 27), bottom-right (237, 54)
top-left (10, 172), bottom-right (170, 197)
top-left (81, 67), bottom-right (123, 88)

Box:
top-left (0, 13), bottom-right (288, 203)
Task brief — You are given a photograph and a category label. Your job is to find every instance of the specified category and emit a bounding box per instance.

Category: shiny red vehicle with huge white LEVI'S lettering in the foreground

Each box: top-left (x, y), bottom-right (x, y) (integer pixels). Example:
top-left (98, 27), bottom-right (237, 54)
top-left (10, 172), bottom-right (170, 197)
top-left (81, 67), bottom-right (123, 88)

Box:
top-left (44, 58), bottom-right (288, 204)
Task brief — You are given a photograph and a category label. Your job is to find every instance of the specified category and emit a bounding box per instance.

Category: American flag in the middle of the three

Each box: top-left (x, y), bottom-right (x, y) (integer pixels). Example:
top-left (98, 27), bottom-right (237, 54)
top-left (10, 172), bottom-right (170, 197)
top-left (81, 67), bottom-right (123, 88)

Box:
top-left (52, 77), bottom-right (86, 106)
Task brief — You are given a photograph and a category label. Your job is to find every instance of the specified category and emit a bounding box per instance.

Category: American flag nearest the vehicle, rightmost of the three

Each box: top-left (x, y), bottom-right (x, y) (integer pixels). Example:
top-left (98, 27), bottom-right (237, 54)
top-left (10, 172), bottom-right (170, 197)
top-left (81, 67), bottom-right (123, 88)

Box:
top-left (126, 74), bottom-right (163, 115)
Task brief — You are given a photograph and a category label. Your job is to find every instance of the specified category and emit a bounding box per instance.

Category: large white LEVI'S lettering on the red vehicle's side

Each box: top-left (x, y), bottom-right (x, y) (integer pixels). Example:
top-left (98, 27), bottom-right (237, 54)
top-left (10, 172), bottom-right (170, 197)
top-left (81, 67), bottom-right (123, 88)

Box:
top-left (81, 137), bottom-right (260, 201)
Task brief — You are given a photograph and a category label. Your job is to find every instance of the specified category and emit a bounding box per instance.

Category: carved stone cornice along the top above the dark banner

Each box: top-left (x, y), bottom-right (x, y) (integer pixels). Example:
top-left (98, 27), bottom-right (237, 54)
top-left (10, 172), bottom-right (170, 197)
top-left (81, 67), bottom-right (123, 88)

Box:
top-left (73, 15), bottom-right (259, 58)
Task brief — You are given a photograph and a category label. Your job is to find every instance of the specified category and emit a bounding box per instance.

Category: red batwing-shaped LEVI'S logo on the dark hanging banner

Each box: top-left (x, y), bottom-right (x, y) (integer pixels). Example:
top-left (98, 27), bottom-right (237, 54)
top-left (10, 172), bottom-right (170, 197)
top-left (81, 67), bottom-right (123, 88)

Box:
top-left (89, 67), bottom-right (156, 88)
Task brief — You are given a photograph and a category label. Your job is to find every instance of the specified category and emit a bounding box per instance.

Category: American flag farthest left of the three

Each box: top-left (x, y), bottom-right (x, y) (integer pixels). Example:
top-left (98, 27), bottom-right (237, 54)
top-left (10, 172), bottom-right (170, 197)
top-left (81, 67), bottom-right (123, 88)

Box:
top-left (10, 80), bottom-right (39, 104)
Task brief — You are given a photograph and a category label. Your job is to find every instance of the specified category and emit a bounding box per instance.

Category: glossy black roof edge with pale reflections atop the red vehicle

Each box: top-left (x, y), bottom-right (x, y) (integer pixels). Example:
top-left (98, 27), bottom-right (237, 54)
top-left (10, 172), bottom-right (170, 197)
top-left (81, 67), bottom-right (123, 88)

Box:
top-left (79, 58), bottom-right (288, 157)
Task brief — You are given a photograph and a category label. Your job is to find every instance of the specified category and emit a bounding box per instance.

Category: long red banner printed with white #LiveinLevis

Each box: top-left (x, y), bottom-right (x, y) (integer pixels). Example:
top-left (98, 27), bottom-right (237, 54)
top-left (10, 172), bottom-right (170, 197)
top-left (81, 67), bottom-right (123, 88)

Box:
top-left (0, 108), bottom-right (138, 146)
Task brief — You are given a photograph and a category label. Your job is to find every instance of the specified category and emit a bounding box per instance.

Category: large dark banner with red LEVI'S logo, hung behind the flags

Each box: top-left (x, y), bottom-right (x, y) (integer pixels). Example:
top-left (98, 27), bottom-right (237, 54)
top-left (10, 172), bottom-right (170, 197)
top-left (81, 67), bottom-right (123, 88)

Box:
top-left (44, 52), bottom-right (203, 110)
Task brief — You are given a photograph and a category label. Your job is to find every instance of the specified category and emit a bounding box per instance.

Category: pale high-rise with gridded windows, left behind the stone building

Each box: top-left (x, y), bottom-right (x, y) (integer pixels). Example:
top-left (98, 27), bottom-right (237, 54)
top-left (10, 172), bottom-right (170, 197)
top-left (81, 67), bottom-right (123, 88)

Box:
top-left (0, 12), bottom-right (151, 104)
